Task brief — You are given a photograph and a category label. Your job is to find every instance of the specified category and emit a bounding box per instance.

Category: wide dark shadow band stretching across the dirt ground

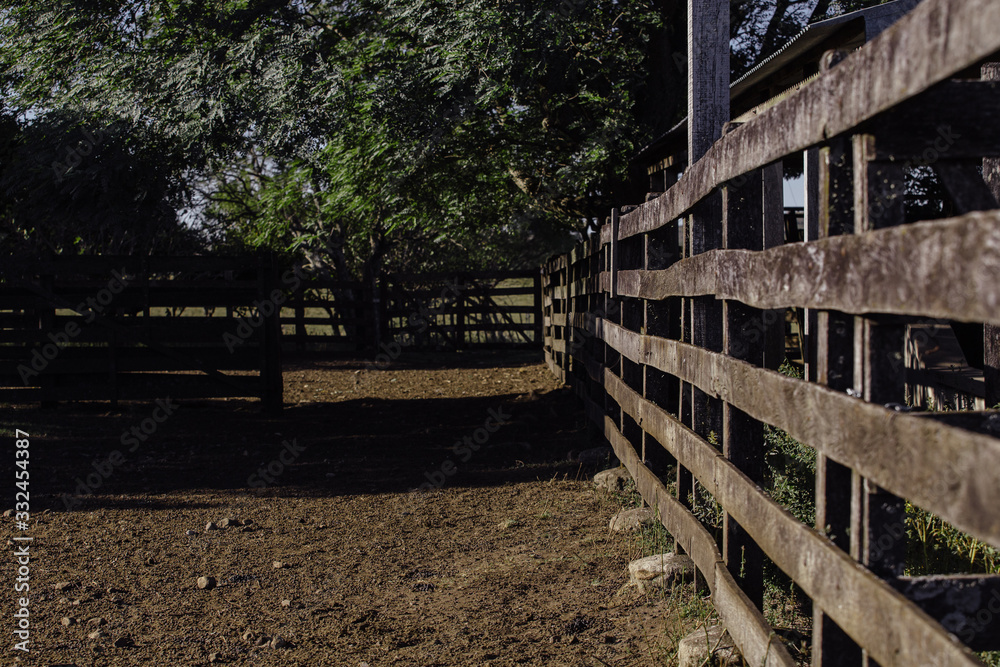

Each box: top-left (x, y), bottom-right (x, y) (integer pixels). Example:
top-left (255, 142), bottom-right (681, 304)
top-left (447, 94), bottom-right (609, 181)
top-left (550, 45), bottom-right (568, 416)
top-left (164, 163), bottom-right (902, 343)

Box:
top-left (2, 355), bottom-right (593, 511)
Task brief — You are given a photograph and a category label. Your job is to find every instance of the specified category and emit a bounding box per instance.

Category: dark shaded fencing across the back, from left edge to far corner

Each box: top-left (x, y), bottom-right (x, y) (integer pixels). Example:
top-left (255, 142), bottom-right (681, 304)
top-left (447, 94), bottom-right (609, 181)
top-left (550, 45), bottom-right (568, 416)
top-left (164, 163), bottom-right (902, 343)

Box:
top-left (0, 256), bottom-right (541, 411)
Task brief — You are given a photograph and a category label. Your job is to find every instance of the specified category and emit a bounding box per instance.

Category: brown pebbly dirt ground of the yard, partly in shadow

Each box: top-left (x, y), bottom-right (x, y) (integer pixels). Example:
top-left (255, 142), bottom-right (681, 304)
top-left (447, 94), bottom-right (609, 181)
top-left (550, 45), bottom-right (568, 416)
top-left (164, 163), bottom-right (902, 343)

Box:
top-left (0, 353), bottom-right (700, 667)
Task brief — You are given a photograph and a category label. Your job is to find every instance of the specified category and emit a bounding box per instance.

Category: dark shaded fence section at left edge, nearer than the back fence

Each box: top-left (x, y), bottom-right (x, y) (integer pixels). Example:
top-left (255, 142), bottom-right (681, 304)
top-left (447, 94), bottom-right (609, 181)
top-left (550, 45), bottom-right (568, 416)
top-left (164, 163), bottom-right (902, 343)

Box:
top-left (0, 256), bottom-right (283, 410)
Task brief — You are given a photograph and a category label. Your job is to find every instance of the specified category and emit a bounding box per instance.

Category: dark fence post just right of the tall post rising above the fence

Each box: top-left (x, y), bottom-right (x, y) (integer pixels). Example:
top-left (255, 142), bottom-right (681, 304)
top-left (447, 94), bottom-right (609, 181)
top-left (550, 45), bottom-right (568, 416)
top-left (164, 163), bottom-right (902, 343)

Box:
top-left (722, 171), bottom-right (768, 608)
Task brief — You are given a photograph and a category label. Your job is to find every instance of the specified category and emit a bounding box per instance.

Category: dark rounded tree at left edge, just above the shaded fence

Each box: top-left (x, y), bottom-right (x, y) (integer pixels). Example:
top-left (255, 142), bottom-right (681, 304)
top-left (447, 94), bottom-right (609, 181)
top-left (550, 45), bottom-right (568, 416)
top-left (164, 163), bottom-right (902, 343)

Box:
top-left (0, 111), bottom-right (196, 255)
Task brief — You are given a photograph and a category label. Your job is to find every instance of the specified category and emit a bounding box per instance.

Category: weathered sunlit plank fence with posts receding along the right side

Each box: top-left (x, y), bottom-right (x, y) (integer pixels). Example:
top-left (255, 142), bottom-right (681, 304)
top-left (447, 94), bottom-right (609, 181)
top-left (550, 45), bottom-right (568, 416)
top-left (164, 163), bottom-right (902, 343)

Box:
top-left (543, 0), bottom-right (1000, 667)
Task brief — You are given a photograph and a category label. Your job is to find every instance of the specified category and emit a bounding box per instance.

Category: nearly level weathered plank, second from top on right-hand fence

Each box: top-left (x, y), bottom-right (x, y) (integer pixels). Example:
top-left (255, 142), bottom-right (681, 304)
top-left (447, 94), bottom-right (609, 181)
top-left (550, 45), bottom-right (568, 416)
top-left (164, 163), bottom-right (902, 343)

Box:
top-left (619, 211), bottom-right (1000, 324)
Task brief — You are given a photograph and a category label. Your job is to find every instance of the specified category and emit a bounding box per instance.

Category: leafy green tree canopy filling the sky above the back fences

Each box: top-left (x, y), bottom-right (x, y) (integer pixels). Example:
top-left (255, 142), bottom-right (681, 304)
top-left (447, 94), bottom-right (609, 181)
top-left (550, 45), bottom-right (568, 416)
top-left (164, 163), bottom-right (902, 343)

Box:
top-left (0, 0), bottom-right (892, 277)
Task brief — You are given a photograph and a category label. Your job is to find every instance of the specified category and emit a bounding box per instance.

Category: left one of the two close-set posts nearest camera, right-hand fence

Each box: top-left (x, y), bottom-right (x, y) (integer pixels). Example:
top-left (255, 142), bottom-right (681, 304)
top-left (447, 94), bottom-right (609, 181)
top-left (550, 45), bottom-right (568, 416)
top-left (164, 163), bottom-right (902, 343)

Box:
top-left (806, 138), bottom-right (861, 667)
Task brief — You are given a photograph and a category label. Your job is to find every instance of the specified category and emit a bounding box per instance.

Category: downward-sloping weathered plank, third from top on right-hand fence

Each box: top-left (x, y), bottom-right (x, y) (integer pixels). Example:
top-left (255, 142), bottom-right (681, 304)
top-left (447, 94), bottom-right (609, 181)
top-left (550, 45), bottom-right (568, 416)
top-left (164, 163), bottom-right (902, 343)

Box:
top-left (590, 318), bottom-right (1000, 547)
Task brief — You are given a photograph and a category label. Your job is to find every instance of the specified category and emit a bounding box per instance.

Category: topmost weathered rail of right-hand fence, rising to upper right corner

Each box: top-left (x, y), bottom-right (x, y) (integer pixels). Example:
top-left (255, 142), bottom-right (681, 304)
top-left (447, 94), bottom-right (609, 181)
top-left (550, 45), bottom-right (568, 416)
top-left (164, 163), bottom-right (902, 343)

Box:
top-left (620, 0), bottom-right (1000, 243)
